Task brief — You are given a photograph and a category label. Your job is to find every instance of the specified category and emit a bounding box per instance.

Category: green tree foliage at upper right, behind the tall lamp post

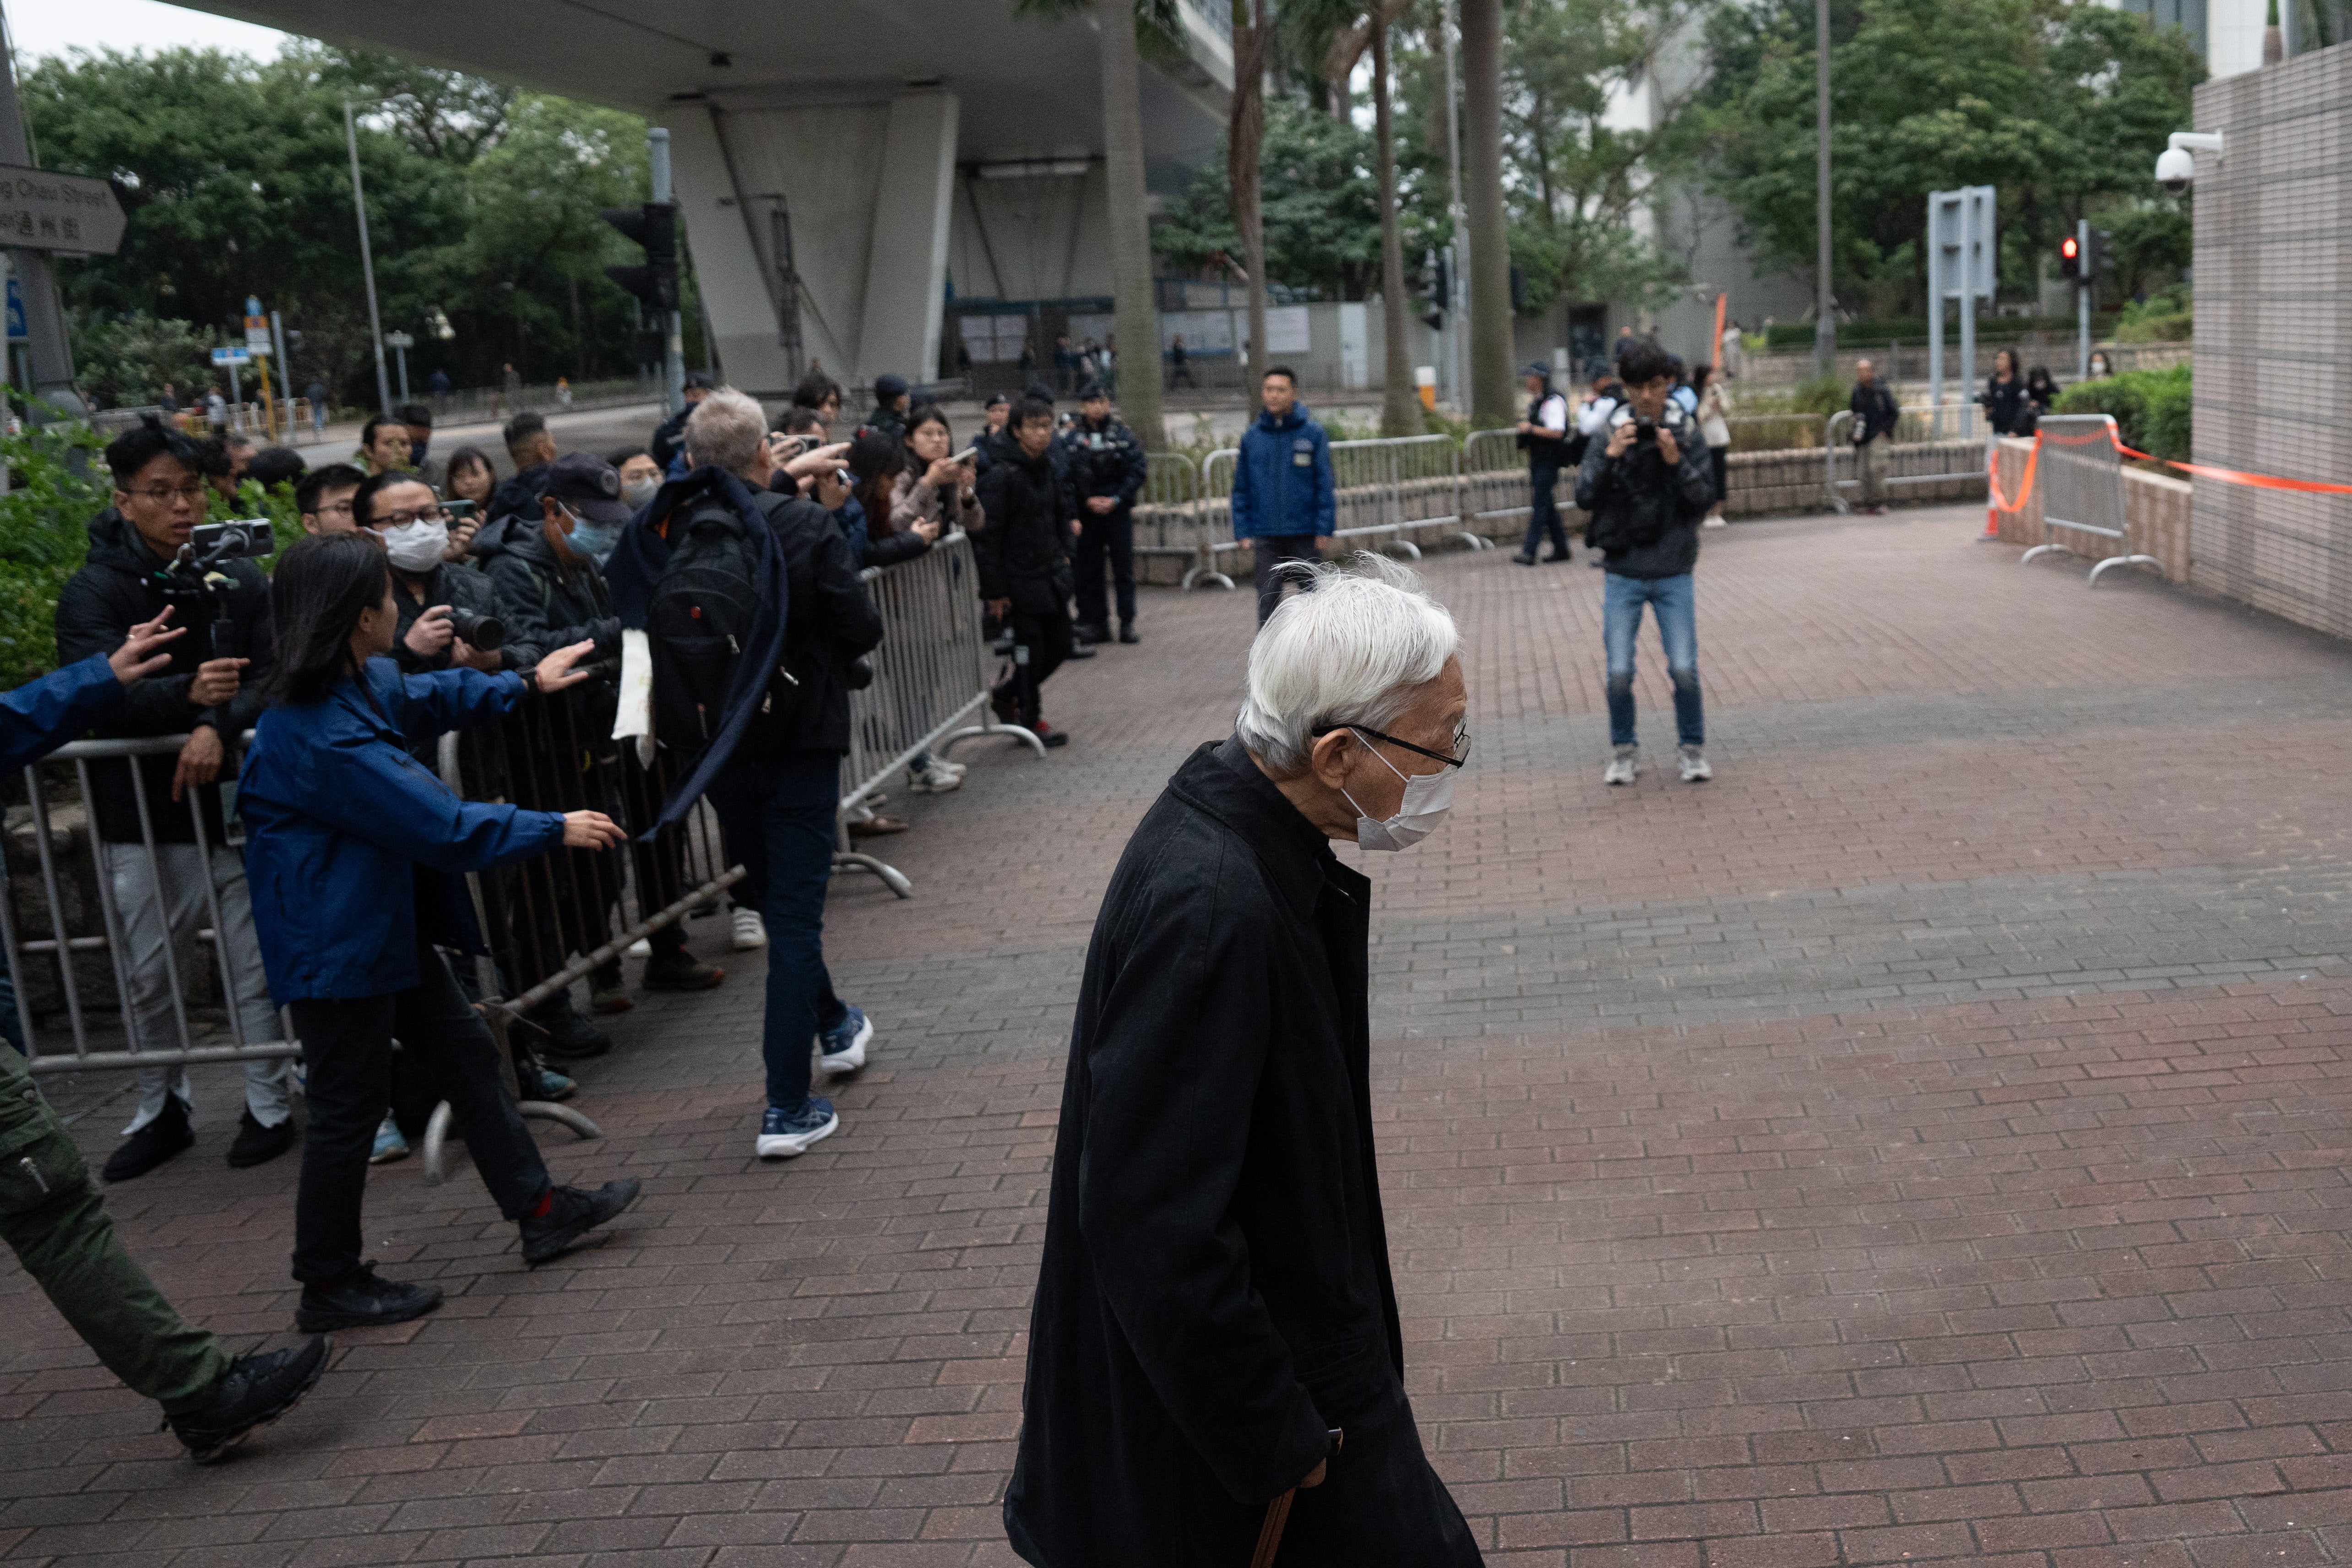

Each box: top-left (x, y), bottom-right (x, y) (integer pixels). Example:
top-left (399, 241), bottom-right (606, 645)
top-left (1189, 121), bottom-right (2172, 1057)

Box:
top-left (1694, 0), bottom-right (2201, 315)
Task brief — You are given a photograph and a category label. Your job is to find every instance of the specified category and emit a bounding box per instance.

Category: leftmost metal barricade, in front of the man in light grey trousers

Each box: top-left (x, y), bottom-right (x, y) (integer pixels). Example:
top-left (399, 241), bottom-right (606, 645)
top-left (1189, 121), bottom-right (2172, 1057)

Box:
top-left (0, 736), bottom-right (301, 1072)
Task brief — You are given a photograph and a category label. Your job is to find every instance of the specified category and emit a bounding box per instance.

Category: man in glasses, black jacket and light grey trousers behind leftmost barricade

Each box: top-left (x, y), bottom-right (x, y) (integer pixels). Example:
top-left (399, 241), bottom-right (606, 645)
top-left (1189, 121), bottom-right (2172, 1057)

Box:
top-left (56, 418), bottom-right (294, 1183)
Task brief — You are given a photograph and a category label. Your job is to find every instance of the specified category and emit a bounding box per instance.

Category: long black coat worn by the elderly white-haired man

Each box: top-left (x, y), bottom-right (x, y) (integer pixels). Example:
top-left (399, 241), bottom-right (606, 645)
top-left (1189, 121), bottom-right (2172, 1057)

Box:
top-left (1006, 738), bottom-right (1477, 1568)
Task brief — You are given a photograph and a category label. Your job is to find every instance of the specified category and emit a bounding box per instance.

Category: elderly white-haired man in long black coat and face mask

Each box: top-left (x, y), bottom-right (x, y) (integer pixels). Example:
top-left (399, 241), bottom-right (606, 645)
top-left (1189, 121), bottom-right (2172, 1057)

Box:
top-left (1004, 557), bottom-right (1479, 1568)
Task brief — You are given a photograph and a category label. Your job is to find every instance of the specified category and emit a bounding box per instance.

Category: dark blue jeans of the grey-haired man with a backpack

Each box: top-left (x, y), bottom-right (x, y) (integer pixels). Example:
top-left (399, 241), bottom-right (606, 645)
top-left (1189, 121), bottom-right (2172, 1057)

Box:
top-left (708, 752), bottom-right (849, 1110)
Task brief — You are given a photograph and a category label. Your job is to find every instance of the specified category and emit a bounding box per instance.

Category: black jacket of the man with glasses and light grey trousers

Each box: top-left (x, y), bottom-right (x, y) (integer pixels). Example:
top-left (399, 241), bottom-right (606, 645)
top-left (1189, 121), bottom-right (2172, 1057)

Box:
top-left (56, 508), bottom-right (271, 844)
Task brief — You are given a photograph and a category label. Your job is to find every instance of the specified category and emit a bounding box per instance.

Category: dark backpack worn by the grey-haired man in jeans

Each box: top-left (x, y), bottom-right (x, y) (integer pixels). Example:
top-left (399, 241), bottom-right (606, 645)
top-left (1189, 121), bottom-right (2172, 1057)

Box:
top-left (645, 501), bottom-right (793, 757)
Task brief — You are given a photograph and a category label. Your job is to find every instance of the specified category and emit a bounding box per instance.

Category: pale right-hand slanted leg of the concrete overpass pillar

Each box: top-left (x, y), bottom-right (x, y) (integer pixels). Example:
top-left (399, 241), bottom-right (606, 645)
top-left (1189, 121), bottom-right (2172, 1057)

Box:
top-left (858, 89), bottom-right (960, 381)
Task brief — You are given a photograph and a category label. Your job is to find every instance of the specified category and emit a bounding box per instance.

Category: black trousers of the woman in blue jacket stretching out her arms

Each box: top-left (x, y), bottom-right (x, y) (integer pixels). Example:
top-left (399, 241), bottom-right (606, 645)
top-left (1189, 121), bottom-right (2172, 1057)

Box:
top-left (292, 940), bottom-right (548, 1284)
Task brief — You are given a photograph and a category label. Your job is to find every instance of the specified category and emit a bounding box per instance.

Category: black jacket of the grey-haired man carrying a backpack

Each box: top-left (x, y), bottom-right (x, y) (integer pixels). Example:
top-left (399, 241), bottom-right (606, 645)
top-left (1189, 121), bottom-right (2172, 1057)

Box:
top-left (736, 491), bottom-right (882, 757)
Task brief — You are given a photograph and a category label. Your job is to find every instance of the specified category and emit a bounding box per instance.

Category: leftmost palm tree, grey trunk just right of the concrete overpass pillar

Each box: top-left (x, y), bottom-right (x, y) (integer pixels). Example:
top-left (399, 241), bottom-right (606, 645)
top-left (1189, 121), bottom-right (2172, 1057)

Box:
top-left (1016, 0), bottom-right (1176, 451)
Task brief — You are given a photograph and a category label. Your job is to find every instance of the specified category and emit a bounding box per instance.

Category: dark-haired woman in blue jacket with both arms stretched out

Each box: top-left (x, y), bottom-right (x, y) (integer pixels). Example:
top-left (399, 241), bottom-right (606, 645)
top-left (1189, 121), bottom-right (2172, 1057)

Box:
top-left (238, 534), bottom-right (637, 1333)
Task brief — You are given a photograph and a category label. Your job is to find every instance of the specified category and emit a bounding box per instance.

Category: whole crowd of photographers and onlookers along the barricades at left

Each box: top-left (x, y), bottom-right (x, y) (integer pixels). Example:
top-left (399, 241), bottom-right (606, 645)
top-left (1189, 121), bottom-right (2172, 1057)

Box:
top-left (0, 350), bottom-right (1195, 1460)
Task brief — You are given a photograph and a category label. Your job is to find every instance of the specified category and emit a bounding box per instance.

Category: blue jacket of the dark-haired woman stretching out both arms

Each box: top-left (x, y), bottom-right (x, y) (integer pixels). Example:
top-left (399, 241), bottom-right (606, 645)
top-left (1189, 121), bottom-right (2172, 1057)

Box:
top-left (238, 658), bottom-right (565, 1006)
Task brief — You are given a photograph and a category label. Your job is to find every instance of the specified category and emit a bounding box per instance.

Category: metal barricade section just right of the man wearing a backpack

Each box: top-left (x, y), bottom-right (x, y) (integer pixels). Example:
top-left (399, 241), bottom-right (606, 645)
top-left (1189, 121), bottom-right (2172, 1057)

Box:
top-left (832, 531), bottom-right (1044, 898)
